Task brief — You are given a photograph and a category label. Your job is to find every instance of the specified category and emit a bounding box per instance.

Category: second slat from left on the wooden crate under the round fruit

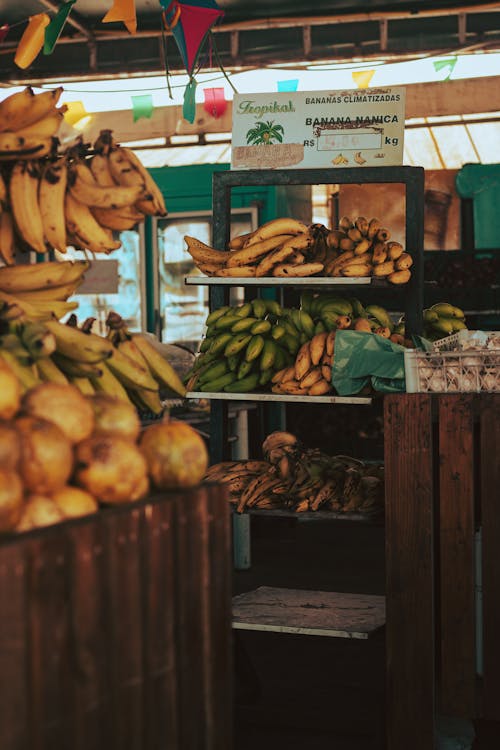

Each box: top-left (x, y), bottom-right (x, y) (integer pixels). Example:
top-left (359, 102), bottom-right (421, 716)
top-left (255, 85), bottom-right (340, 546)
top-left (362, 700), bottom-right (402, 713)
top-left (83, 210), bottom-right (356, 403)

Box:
top-left (27, 530), bottom-right (74, 750)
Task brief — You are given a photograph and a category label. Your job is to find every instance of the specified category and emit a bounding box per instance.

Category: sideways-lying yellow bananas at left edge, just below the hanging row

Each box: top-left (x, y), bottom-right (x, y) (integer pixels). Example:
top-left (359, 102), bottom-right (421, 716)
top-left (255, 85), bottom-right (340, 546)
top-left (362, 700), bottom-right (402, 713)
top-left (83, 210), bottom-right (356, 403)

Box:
top-left (0, 260), bottom-right (90, 321)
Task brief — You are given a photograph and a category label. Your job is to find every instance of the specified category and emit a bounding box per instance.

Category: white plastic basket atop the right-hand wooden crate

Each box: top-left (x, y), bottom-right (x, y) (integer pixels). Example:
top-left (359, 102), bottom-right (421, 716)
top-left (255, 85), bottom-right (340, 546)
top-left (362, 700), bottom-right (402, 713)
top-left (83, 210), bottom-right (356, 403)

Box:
top-left (404, 349), bottom-right (500, 393)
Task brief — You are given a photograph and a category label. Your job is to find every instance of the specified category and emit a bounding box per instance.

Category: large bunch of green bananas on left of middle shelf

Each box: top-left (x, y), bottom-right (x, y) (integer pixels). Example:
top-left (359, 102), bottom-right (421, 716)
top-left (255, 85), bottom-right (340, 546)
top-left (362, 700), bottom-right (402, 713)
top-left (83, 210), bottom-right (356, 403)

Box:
top-left (186, 299), bottom-right (307, 393)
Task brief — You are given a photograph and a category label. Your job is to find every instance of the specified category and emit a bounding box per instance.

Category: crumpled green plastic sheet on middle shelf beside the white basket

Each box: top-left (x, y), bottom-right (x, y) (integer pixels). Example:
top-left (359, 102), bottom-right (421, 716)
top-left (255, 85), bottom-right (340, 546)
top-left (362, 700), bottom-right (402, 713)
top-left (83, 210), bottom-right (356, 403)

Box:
top-left (332, 330), bottom-right (406, 396)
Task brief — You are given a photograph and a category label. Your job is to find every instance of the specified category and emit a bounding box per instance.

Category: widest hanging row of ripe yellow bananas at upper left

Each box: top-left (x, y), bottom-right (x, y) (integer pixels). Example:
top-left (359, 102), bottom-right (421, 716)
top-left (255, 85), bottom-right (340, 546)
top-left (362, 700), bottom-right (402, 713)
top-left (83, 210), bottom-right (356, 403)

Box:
top-left (0, 126), bottom-right (166, 265)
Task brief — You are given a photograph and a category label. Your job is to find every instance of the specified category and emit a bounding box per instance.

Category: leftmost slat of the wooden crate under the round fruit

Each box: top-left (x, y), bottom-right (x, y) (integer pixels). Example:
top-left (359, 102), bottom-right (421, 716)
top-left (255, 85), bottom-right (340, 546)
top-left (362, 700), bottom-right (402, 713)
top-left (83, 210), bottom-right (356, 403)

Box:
top-left (0, 542), bottom-right (30, 750)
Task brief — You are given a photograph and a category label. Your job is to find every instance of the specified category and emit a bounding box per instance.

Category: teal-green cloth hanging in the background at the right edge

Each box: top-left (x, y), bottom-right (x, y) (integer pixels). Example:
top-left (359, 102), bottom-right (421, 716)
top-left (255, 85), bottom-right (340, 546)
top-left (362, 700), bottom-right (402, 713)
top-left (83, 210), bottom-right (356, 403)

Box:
top-left (455, 164), bottom-right (500, 250)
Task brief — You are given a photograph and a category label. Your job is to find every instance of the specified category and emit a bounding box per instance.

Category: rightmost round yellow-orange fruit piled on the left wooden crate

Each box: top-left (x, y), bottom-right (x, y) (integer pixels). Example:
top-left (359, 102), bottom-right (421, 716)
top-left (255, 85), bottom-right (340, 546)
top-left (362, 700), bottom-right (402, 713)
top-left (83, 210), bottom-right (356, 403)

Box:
top-left (139, 420), bottom-right (208, 490)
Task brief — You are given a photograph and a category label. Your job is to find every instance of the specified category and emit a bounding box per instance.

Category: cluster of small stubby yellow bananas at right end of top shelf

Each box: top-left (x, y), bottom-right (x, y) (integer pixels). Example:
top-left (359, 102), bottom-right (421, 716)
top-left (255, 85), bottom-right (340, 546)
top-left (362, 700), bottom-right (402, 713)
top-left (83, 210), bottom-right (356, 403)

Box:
top-left (324, 216), bottom-right (413, 284)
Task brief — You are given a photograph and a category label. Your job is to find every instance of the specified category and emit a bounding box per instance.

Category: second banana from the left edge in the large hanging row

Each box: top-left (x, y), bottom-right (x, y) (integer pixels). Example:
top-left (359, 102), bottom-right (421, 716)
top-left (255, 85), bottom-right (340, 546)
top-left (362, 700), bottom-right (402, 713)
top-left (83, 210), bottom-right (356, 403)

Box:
top-left (10, 161), bottom-right (47, 254)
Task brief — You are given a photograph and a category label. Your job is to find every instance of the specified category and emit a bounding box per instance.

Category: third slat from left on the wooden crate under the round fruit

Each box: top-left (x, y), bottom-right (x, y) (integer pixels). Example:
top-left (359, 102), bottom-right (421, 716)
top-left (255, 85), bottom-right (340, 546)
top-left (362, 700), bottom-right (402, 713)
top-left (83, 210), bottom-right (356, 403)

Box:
top-left (69, 518), bottom-right (113, 750)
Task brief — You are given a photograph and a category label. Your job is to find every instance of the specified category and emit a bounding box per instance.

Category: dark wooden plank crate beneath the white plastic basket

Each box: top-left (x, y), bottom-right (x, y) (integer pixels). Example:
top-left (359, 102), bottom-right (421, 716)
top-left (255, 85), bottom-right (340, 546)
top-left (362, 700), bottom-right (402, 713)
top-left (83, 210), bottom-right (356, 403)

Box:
top-left (384, 393), bottom-right (500, 750)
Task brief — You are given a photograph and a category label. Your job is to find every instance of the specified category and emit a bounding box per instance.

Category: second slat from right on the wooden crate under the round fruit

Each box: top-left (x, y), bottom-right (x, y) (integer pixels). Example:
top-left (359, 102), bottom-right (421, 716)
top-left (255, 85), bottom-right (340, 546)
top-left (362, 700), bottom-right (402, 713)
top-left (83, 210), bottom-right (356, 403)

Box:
top-left (176, 487), bottom-right (211, 750)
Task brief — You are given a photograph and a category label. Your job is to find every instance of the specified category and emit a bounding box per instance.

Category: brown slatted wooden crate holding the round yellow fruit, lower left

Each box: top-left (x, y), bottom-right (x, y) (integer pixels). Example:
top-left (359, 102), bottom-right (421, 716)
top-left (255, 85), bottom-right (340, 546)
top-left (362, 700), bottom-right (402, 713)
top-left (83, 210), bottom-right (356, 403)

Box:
top-left (0, 485), bottom-right (232, 750)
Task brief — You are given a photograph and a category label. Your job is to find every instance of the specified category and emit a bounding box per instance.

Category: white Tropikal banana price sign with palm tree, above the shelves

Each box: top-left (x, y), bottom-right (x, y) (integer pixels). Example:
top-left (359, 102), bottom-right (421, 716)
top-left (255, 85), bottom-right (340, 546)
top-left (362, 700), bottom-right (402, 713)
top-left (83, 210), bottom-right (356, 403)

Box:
top-left (231, 87), bottom-right (405, 169)
